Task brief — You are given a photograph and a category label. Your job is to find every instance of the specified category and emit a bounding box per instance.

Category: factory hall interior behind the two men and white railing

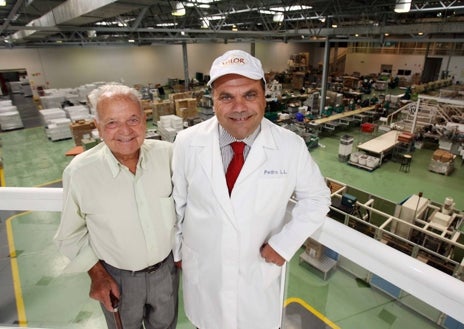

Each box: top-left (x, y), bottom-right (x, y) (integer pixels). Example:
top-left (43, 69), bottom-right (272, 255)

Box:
top-left (0, 0), bottom-right (464, 329)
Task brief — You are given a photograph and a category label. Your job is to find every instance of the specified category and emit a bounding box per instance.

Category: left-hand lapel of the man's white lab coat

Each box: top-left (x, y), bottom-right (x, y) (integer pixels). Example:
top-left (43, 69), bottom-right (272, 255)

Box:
top-left (195, 117), bottom-right (236, 226)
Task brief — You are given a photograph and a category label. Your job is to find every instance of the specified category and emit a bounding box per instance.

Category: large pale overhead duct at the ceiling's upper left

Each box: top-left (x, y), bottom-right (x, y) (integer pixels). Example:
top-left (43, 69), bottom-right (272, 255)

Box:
top-left (11, 0), bottom-right (153, 41)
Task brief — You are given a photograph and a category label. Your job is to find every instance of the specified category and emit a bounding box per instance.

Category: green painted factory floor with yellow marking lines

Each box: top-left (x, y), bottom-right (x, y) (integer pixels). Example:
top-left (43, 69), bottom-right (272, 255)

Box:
top-left (0, 94), bottom-right (464, 329)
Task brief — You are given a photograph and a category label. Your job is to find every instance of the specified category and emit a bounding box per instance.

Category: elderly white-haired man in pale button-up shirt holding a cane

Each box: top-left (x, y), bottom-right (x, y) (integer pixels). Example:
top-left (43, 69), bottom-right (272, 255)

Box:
top-left (55, 84), bottom-right (178, 329)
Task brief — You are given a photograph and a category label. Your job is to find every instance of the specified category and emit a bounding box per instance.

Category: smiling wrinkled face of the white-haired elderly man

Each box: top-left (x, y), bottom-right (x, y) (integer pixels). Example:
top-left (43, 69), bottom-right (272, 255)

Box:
top-left (97, 95), bottom-right (146, 162)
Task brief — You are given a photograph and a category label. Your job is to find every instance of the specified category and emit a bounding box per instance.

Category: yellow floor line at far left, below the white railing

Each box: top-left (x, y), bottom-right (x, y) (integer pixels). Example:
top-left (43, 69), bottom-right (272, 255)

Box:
top-left (5, 212), bottom-right (27, 327)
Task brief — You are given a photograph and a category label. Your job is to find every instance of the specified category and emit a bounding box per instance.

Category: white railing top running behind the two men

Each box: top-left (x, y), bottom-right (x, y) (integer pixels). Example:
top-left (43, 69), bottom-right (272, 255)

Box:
top-left (0, 187), bottom-right (464, 323)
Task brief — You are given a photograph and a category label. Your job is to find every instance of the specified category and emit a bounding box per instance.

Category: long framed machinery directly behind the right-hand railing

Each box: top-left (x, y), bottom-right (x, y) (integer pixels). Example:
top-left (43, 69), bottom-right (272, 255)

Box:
top-left (327, 178), bottom-right (464, 281)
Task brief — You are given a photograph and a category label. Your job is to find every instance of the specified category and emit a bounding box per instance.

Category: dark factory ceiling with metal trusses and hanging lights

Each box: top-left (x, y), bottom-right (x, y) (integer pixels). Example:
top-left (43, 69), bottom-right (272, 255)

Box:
top-left (0, 0), bottom-right (464, 48)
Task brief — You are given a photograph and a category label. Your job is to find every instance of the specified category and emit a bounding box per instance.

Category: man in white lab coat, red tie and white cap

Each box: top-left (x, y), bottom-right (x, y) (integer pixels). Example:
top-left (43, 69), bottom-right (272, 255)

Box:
top-left (173, 50), bottom-right (330, 329)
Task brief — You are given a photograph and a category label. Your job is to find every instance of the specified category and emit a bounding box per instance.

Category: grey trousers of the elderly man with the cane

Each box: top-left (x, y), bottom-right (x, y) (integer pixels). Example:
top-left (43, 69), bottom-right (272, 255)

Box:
top-left (102, 254), bottom-right (179, 329)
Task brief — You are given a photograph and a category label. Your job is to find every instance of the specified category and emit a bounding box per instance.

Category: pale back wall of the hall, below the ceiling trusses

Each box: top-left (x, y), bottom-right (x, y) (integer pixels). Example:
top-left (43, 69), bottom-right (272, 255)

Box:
top-left (0, 42), bottom-right (464, 88)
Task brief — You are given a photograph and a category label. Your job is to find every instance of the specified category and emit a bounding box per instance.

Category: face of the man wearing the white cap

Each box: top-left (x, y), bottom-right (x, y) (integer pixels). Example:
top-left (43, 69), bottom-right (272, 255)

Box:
top-left (213, 74), bottom-right (266, 139)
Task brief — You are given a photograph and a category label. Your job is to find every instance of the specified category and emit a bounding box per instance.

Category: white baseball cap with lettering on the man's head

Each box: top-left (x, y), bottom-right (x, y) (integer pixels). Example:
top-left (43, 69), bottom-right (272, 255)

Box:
top-left (208, 50), bottom-right (266, 86)
